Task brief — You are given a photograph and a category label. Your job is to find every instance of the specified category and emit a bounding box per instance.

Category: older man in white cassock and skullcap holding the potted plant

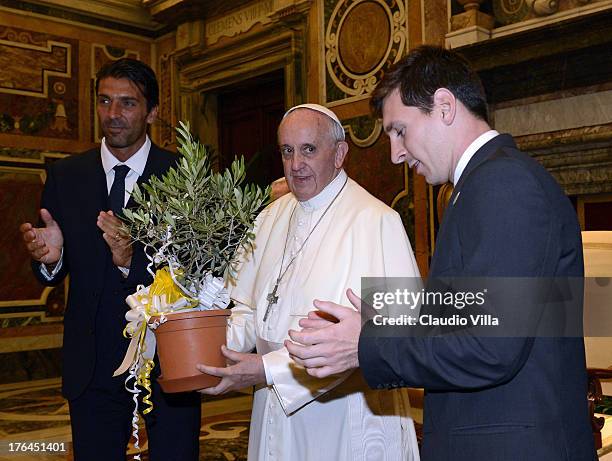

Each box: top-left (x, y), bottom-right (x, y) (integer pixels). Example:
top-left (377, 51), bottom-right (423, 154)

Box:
top-left (198, 104), bottom-right (419, 461)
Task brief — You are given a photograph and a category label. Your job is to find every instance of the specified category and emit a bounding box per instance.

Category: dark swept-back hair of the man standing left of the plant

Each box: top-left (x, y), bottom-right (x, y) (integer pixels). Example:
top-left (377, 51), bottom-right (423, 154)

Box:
top-left (96, 58), bottom-right (159, 112)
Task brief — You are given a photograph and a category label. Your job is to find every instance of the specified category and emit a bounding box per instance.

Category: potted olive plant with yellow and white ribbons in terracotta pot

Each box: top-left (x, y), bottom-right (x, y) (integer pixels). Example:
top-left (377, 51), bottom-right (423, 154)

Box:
top-left (115, 123), bottom-right (269, 402)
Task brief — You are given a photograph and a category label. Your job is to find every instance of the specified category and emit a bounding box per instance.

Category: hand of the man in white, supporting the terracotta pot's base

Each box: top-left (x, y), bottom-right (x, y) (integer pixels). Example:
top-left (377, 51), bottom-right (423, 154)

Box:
top-left (196, 346), bottom-right (266, 395)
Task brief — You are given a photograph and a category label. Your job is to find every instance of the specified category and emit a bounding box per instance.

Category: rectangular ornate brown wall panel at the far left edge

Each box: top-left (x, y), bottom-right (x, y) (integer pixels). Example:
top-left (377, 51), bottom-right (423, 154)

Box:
top-left (0, 26), bottom-right (79, 139)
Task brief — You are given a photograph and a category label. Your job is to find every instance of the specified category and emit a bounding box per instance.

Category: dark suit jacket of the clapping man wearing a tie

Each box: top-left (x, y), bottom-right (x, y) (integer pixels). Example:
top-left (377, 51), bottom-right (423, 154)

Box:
top-left (33, 145), bottom-right (176, 399)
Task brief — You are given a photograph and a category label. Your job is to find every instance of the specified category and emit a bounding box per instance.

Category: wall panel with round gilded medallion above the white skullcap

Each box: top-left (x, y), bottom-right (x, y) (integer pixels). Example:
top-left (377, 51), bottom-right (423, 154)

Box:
top-left (324, 0), bottom-right (408, 106)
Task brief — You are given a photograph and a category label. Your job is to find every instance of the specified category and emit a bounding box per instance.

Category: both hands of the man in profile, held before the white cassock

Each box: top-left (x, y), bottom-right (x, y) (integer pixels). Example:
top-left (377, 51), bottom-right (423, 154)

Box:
top-left (285, 289), bottom-right (361, 378)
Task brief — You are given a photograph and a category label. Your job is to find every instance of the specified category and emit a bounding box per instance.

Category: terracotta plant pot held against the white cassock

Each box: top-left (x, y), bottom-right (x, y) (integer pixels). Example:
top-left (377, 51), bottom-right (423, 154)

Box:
top-left (150, 309), bottom-right (231, 392)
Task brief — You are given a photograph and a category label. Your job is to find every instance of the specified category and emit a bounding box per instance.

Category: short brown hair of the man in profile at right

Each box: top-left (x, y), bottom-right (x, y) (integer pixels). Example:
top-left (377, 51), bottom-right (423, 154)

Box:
top-left (370, 45), bottom-right (489, 121)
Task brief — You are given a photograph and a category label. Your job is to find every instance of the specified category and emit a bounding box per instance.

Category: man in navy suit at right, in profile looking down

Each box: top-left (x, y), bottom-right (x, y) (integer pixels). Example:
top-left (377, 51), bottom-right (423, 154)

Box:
top-left (287, 46), bottom-right (596, 461)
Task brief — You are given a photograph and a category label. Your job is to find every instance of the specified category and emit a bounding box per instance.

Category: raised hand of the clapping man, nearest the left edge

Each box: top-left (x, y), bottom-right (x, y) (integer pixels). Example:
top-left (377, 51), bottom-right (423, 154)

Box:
top-left (19, 208), bottom-right (64, 265)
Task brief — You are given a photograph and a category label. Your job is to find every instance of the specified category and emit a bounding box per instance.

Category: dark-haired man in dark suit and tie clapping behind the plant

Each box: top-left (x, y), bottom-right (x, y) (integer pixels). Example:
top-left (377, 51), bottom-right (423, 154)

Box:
top-left (20, 59), bottom-right (200, 461)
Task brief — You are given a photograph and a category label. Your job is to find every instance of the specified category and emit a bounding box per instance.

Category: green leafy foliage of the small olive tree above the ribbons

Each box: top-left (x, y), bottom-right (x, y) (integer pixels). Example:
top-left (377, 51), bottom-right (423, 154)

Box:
top-left (124, 122), bottom-right (270, 287)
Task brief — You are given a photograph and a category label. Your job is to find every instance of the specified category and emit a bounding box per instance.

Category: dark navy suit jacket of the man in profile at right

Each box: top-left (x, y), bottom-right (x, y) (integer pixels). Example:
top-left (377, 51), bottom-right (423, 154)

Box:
top-left (359, 135), bottom-right (596, 461)
